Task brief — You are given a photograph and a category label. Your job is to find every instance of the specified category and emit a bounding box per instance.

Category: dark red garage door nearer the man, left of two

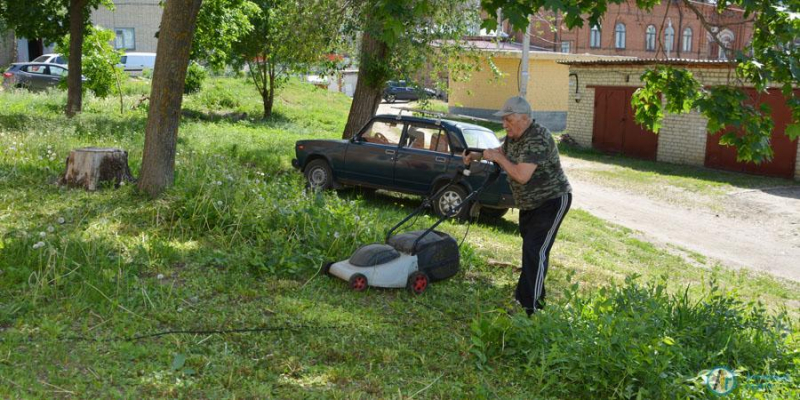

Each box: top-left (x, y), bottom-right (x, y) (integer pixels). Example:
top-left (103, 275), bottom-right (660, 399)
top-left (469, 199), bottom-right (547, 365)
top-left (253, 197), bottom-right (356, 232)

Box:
top-left (592, 86), bottom-right (658, 160)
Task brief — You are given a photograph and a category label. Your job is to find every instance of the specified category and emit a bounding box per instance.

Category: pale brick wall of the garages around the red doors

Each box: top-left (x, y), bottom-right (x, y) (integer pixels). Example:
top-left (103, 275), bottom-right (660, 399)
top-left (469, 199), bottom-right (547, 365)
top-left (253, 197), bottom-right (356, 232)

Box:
top-left (566, 65), bottom-right (800, 179)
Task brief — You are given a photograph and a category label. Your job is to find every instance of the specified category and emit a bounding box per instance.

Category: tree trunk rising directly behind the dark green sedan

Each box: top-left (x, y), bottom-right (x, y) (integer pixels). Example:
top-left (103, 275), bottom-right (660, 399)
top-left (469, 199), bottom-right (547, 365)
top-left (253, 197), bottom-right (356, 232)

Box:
top-left (342, 32), bottom-right (388, 139)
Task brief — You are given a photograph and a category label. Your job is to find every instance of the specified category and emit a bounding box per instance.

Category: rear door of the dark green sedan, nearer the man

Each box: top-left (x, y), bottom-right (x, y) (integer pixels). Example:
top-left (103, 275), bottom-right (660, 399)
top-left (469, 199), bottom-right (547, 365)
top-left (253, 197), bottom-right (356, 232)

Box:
top-left (394, 122), bottom-right (453, 193)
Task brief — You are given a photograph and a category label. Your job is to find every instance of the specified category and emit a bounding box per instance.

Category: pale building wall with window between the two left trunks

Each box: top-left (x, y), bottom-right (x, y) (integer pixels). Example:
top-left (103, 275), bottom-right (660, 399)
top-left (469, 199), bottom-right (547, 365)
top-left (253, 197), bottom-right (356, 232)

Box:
top-left (92, 0), bottom-right (163, 53)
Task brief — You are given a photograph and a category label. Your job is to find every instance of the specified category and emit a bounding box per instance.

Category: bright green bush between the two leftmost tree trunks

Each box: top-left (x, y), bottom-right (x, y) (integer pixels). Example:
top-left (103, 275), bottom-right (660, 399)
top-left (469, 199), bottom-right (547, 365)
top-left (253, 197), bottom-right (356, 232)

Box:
top-left (56, 25), bottom-right (127, 98)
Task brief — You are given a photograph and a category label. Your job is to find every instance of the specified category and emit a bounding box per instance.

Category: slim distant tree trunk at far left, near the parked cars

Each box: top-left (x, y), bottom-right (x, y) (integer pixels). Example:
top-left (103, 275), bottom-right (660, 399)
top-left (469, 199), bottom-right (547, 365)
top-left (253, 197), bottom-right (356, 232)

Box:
top-left (66, 0), bottom-right (86, 117)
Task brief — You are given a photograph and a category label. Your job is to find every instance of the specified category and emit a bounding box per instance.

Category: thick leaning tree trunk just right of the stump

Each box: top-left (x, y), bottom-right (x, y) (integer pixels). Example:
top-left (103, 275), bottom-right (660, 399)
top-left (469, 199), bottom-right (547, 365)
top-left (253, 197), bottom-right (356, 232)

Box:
top-left (139, 0), bottom-right (202, 196)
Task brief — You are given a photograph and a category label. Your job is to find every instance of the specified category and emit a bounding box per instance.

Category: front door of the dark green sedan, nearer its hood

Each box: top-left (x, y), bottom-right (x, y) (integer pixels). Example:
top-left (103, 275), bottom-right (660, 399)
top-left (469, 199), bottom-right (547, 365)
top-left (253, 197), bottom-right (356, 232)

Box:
top-left (341, 119), bottom-right (405, 187)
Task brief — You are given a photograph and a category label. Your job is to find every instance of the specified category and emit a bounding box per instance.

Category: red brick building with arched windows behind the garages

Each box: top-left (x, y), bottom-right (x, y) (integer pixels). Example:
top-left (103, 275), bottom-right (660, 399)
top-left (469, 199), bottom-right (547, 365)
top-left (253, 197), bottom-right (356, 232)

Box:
top-left (503, 0), bottom-right (753, 60)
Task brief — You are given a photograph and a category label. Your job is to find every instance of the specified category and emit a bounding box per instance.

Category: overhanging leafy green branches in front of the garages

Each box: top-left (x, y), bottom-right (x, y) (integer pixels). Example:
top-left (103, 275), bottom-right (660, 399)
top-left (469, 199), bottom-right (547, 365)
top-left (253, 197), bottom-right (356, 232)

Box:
top-left (481, 0), bottom-right (800, 162)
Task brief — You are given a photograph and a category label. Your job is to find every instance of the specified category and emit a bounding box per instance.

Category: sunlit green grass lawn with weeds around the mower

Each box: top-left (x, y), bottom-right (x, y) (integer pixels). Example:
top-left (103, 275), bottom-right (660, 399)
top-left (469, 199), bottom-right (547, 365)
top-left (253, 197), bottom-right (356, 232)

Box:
top-left (0, 78), bottom-right (800, 399)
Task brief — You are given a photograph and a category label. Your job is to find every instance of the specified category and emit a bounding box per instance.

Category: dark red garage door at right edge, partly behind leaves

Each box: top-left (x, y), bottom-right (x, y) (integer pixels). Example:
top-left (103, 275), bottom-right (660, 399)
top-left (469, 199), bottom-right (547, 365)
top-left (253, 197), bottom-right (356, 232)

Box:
top-left (705, 89), bottom-right (797, 178)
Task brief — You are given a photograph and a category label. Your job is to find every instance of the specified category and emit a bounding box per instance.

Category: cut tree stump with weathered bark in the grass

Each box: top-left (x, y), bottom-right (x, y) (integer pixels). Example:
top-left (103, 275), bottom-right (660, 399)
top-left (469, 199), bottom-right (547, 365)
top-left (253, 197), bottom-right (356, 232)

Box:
top-left (59, 147), bottom-right (134, 191)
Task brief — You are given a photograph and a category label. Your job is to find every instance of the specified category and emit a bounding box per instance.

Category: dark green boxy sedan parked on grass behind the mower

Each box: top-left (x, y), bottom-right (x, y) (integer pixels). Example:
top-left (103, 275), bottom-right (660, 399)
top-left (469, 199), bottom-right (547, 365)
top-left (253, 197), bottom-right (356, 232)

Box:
top-left (292, 115), bottom-right (514, 219)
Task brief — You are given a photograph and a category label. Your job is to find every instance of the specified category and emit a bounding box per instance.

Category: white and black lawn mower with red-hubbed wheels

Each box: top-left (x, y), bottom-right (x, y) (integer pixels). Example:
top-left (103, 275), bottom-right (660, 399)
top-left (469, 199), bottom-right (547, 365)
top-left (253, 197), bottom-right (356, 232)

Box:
top-left (321, 149), bottom-right (500, 294)
